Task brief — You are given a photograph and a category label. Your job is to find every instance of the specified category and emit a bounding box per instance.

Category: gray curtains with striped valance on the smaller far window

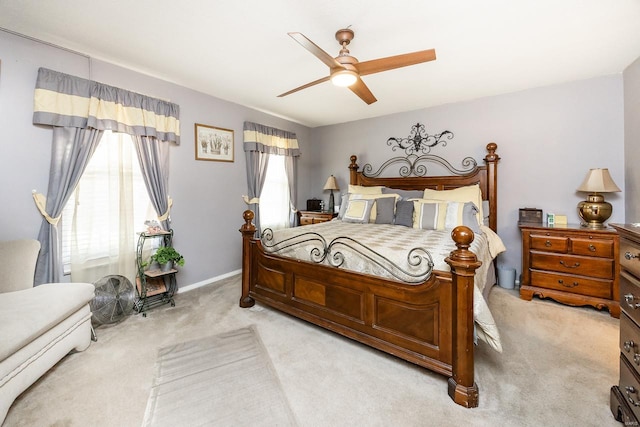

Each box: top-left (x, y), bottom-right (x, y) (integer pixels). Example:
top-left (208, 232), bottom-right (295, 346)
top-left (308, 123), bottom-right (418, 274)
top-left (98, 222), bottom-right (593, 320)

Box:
top-left (244, 122), bottom-right (300, 233)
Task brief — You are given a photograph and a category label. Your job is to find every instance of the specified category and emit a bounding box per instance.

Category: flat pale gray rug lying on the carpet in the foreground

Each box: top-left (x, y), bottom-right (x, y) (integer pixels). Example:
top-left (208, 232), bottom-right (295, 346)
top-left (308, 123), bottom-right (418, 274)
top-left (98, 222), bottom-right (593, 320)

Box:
top-left (143, 325), bottom-right (297, 426)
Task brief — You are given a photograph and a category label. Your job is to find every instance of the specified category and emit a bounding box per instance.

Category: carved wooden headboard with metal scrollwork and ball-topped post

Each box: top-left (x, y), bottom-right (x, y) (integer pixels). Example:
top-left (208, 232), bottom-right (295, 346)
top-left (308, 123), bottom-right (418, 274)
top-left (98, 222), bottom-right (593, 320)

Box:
top-left (349, 142), bottom-right (500, 232)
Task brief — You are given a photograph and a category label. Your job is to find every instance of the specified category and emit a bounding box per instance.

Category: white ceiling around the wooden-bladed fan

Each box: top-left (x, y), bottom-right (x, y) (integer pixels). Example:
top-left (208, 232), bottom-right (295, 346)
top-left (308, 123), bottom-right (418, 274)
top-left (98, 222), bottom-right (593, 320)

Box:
top-left (0, 0), bottom-right (640, 127)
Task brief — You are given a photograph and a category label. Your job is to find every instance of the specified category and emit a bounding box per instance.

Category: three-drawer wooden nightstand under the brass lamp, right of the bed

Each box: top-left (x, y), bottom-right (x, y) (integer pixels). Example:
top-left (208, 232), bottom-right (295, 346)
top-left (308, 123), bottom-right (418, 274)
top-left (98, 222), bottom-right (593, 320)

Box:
top-left (518, 223), bottom-right (620, 318)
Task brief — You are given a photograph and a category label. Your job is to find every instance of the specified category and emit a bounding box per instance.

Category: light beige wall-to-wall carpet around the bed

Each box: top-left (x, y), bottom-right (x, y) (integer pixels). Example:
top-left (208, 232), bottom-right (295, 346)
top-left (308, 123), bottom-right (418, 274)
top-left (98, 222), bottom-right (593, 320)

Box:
top-left (0, 276), bottom-right (621, 427)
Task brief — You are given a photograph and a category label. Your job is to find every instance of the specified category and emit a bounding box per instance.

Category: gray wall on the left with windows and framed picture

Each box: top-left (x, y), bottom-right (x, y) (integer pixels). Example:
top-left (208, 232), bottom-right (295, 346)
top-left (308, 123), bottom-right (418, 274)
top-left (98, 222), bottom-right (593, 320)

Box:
top-left (0, 31), bottom-right (311, 286)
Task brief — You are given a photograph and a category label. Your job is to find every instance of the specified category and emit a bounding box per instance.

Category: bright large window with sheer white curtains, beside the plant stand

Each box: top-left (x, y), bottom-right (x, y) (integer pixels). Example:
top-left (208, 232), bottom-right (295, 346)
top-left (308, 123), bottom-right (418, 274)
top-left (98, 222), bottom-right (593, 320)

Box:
top-left (61, 131), bottom-right (155, 282)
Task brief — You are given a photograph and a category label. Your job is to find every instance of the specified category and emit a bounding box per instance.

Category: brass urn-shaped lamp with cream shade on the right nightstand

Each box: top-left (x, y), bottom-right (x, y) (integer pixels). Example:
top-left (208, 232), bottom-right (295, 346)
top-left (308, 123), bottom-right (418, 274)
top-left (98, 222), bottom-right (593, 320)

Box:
top-left (577, 169), bottom-right (622, 228)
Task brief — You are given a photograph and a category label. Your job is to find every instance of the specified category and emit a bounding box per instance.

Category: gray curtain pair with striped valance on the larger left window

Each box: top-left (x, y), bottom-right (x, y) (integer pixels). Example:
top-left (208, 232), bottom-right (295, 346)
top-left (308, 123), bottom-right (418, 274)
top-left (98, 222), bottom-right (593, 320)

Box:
top-left (33, 68), bottom-right (180, 285)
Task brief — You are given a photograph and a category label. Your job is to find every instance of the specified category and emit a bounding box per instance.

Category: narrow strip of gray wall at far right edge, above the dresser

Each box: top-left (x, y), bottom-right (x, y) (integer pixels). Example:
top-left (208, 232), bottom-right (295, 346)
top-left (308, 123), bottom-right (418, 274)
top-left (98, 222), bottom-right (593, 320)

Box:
top-left (623, 58), bottom-right (640, 223)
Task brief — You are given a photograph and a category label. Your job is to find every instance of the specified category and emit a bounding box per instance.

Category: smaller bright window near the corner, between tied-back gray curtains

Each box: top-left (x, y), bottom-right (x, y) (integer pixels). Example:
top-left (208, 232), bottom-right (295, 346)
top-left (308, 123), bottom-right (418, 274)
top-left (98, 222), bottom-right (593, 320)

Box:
top-left (260, 155), bottom-right (291, 230)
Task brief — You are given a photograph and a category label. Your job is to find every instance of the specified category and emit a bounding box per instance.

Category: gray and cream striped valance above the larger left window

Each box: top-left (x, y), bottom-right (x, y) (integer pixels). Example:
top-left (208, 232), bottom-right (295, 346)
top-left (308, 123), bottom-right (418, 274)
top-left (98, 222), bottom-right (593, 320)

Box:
top-left (33, 68), bottom-right (180, 143)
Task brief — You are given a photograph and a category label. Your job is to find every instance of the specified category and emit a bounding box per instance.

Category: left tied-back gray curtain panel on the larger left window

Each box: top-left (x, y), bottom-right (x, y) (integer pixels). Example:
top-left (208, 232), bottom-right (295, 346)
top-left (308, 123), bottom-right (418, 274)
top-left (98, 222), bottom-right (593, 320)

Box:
top-left (34, 127), bottom-right (104, 285)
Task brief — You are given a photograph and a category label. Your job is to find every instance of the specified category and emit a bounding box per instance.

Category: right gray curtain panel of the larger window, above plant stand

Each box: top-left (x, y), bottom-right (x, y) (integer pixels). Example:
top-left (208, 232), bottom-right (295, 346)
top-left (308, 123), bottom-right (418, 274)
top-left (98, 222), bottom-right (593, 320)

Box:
top-left (132, 135), bottom-right (171, 230)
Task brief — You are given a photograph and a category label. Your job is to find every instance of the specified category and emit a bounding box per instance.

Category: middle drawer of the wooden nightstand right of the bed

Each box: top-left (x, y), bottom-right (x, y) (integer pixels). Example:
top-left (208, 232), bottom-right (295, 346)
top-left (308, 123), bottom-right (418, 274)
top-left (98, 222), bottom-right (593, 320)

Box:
top-left (531, 251), bottom-right (615, 279)
